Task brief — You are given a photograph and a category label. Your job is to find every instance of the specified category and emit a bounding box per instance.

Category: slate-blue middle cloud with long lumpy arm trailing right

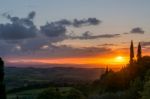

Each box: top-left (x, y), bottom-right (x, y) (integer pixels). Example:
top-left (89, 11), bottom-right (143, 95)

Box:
top-left (40, 18), bottom-right (101, 42)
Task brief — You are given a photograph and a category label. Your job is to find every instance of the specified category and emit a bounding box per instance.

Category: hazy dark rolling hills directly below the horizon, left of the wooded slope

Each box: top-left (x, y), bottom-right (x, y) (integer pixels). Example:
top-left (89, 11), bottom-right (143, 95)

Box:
top-left (5, 67), bottom-right (104, 89)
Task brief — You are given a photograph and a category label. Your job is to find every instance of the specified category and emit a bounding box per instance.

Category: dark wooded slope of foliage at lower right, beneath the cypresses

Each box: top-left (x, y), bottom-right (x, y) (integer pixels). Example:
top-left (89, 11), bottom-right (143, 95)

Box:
top-left (93, 55), bottom-right (150, 99)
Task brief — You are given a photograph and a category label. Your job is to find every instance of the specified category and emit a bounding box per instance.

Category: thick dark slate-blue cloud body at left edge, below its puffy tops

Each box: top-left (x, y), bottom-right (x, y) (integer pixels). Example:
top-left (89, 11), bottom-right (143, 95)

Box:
top-left (0, 24), bottom-right (36, 40)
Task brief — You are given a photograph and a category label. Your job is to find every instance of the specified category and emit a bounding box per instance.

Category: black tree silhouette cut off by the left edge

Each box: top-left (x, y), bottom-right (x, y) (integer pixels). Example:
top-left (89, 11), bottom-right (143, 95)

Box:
top-left (0, 57), bottom-right (6, 99)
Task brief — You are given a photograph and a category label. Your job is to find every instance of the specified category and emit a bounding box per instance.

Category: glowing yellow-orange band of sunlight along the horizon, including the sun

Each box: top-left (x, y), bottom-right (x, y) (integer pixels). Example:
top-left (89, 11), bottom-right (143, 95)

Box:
top-left (7, 56), bottom-right (128, 68)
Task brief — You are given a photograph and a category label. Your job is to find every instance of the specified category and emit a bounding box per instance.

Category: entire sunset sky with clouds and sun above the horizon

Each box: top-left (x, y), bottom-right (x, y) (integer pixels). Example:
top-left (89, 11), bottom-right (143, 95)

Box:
top-left (0, 0), bottom-right (150, 67)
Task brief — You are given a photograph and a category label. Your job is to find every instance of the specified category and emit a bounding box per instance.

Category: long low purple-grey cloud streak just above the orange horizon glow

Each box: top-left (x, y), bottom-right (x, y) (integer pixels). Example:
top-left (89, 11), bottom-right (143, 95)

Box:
top-left (17, 45), bottom-right (111, 58)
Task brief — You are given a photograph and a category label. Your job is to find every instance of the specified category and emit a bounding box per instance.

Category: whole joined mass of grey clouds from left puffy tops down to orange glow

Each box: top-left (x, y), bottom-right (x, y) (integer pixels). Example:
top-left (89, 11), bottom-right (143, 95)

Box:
top-left (0, 11), bottom-right (105, 57)
